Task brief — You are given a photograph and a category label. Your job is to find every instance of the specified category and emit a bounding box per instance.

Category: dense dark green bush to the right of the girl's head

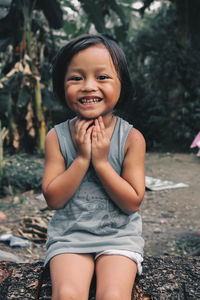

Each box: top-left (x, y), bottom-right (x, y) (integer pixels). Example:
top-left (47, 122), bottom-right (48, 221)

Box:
top-left (122, 2), bottom-right (200, 151)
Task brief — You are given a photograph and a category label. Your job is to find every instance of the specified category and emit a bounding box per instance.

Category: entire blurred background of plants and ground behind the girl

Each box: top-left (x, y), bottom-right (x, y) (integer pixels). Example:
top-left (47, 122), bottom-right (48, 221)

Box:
top-left (0, 0), bottom-right (200, 262)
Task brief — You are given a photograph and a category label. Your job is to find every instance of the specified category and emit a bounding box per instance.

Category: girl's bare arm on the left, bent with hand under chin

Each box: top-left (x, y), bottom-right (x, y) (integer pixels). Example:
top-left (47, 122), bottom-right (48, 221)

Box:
top-left (42, 120), bottom-right (92, 209)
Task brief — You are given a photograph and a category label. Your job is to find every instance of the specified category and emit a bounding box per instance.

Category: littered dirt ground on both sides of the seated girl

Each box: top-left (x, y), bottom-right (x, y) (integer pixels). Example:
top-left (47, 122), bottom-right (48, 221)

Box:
top-left (0, 153), bottom-right (200, 262)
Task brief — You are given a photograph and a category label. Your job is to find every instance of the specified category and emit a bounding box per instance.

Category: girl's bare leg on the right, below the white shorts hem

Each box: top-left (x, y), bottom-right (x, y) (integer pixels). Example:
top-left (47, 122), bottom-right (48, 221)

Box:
top-left (96, 255), bottom-right (137, 300)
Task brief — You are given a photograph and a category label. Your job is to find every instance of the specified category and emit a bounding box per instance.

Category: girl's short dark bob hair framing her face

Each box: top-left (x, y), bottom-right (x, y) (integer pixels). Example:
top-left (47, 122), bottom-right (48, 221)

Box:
top-left (52, 34), bottom-right (133, 107)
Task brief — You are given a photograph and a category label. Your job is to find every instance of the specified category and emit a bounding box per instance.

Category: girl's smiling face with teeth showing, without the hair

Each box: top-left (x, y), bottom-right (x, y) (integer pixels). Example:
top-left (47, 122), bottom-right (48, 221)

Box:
top-left (64, 44), bottom-right (121, 119)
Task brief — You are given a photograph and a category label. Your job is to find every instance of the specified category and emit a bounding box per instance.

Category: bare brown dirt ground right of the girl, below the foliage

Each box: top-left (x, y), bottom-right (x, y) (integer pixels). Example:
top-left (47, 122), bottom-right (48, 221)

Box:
top-left (141, 153), bottom-right (200, 256)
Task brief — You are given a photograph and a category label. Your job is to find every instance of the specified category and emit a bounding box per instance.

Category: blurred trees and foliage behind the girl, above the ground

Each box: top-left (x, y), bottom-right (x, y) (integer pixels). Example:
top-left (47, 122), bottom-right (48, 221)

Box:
top-left (0, 0), bottom-right (200, 154)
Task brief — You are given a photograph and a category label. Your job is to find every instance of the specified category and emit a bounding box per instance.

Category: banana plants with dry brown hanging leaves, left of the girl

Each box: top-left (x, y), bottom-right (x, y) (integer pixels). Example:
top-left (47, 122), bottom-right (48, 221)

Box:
top-left (0, 0), bottom-right (63, 152)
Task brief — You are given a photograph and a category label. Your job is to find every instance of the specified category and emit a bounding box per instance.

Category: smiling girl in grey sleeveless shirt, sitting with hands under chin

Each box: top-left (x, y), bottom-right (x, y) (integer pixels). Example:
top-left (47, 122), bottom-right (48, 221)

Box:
top-left (43, 35), bottom-right (145, 300)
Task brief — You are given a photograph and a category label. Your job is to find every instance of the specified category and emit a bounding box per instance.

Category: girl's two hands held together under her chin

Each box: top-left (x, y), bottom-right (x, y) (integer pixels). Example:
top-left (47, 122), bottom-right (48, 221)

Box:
top-left (75, 116), bottom-right (110, 168)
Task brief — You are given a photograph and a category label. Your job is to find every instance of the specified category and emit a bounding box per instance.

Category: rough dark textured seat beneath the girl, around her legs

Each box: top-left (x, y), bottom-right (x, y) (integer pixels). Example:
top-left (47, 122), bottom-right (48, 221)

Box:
top-left (0, 256), bottom-right (200, 300)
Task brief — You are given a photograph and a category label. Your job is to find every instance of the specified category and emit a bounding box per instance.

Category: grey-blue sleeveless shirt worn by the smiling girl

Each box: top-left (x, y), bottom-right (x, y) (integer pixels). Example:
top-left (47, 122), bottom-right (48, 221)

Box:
top-left (44, 117), bottom-right (144, 265)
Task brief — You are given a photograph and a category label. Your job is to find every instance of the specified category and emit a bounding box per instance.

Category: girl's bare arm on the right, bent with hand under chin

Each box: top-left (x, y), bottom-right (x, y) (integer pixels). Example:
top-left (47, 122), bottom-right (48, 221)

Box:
top-left (92, 119), bottom-right (145, 214)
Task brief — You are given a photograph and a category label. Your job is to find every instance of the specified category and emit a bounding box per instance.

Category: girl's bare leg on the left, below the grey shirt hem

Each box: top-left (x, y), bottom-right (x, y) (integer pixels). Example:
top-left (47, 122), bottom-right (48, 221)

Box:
top-left (50, 254), bottom-right (94, 300)
